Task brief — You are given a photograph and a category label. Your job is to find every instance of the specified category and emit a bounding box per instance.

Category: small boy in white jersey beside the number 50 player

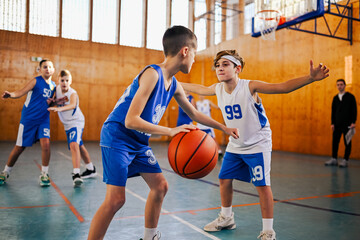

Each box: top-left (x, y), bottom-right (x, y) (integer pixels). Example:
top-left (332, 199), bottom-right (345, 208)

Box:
top-left (48, 70), bottom-right (97, 187)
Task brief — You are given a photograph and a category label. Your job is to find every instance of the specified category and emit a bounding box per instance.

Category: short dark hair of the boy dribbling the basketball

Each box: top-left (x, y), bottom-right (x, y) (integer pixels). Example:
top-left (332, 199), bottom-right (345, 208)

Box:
top-left (162, 26), bottom-right (197, 57)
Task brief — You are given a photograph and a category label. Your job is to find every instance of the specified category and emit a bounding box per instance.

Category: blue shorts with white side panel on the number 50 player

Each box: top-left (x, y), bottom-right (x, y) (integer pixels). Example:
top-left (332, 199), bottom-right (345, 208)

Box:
top-left (16, 122), bottom-right (50, 147)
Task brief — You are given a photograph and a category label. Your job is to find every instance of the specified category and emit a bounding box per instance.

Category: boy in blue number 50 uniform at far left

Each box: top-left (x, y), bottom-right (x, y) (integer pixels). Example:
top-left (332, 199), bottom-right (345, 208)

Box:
top-left (0, 59), bottom-right (55, 186)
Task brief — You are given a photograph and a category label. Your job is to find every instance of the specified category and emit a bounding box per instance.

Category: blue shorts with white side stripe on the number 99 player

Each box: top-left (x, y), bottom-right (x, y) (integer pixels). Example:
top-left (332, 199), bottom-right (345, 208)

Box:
top-left (219, 152), bottom-right (271, 187)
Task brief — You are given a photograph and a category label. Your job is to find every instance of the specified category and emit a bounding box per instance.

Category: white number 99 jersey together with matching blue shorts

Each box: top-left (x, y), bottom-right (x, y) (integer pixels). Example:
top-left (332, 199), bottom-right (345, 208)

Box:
top-left (215, 79), bottom-right (272, 186)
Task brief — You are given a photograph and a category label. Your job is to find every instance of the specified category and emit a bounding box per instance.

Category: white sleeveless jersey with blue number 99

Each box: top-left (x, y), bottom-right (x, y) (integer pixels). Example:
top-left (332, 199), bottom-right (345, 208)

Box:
top-left (215, 79), bottom-right (272, 154)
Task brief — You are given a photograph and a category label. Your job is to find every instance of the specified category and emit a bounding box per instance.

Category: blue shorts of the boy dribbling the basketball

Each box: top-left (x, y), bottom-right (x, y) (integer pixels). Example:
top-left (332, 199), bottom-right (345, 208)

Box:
top-left (101, 146), bottom-right (162, 187)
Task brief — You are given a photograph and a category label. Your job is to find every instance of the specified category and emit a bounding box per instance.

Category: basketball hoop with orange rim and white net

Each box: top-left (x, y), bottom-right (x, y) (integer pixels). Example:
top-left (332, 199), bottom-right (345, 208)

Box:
top-left (255, 10), bottom-right (281, 41)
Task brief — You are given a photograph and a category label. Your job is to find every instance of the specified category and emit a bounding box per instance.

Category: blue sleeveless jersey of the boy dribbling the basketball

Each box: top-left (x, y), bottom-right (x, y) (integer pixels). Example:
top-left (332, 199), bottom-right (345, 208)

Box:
top-left (100, 65), bottom-right (177, 148)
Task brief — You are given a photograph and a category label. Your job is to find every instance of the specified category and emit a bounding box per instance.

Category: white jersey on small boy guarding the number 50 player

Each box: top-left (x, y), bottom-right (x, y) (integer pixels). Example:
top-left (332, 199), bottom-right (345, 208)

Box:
top-left (56, 85), bottom-right (85, 131)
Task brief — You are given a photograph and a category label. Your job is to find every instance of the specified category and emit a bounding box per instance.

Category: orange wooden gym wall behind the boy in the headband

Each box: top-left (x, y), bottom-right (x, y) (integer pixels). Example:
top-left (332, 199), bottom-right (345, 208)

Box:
top-left (190, 6), bottom-right (360, 159)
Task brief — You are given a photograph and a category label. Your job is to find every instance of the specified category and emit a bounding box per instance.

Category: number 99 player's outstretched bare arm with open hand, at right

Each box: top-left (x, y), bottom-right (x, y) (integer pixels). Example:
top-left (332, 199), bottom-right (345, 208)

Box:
top-left (249, 60), bottom-right (330, 94)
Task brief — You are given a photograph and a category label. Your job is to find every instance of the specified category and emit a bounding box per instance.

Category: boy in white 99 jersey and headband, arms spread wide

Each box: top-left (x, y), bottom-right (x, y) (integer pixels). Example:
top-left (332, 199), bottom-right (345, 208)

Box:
top-left (182, 50), bottom-right (329, 240)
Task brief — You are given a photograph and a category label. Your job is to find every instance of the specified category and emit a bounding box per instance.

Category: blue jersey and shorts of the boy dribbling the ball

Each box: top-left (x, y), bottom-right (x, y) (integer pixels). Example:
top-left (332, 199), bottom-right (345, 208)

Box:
top-left (100, 65), bottom-right (177, 186)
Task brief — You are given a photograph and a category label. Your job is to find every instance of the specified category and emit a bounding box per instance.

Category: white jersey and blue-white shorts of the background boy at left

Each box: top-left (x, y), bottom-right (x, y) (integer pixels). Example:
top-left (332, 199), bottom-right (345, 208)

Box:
top-left (56, 85), bottom-right (85, 148)
